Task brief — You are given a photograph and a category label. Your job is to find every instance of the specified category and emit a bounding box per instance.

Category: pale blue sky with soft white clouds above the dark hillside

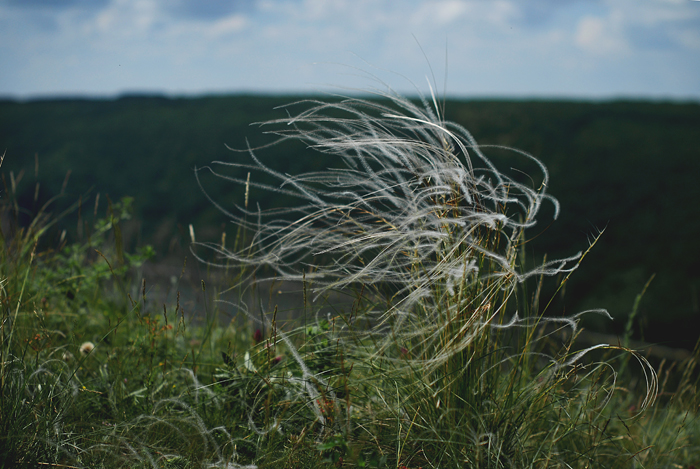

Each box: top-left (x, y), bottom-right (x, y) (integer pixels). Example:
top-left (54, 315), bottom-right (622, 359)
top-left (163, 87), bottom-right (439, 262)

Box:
top-left (0, 0), bottom-right (700, 100)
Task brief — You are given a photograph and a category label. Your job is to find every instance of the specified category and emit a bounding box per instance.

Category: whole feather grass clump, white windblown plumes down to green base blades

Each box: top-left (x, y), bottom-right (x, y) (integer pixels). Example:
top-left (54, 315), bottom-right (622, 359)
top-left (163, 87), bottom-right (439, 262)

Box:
top-left (193, 82), bottom-right (668, 467)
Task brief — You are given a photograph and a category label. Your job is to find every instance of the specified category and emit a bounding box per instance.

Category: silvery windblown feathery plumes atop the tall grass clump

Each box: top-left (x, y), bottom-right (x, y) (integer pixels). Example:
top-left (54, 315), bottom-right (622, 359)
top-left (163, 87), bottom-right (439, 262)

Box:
top-left (198, 84), bottom-right (581, 346)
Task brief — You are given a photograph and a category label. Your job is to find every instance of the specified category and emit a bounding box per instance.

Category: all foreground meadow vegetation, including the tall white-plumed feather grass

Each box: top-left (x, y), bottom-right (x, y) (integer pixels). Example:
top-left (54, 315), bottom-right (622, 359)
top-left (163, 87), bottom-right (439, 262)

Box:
top-left (0, 88), bottom-right (700, 469)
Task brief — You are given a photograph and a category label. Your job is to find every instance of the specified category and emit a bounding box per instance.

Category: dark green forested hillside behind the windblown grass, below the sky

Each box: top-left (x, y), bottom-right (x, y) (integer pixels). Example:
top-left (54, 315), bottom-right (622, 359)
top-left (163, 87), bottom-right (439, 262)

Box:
top-left (0, 95), bottom-right (700, 347)
